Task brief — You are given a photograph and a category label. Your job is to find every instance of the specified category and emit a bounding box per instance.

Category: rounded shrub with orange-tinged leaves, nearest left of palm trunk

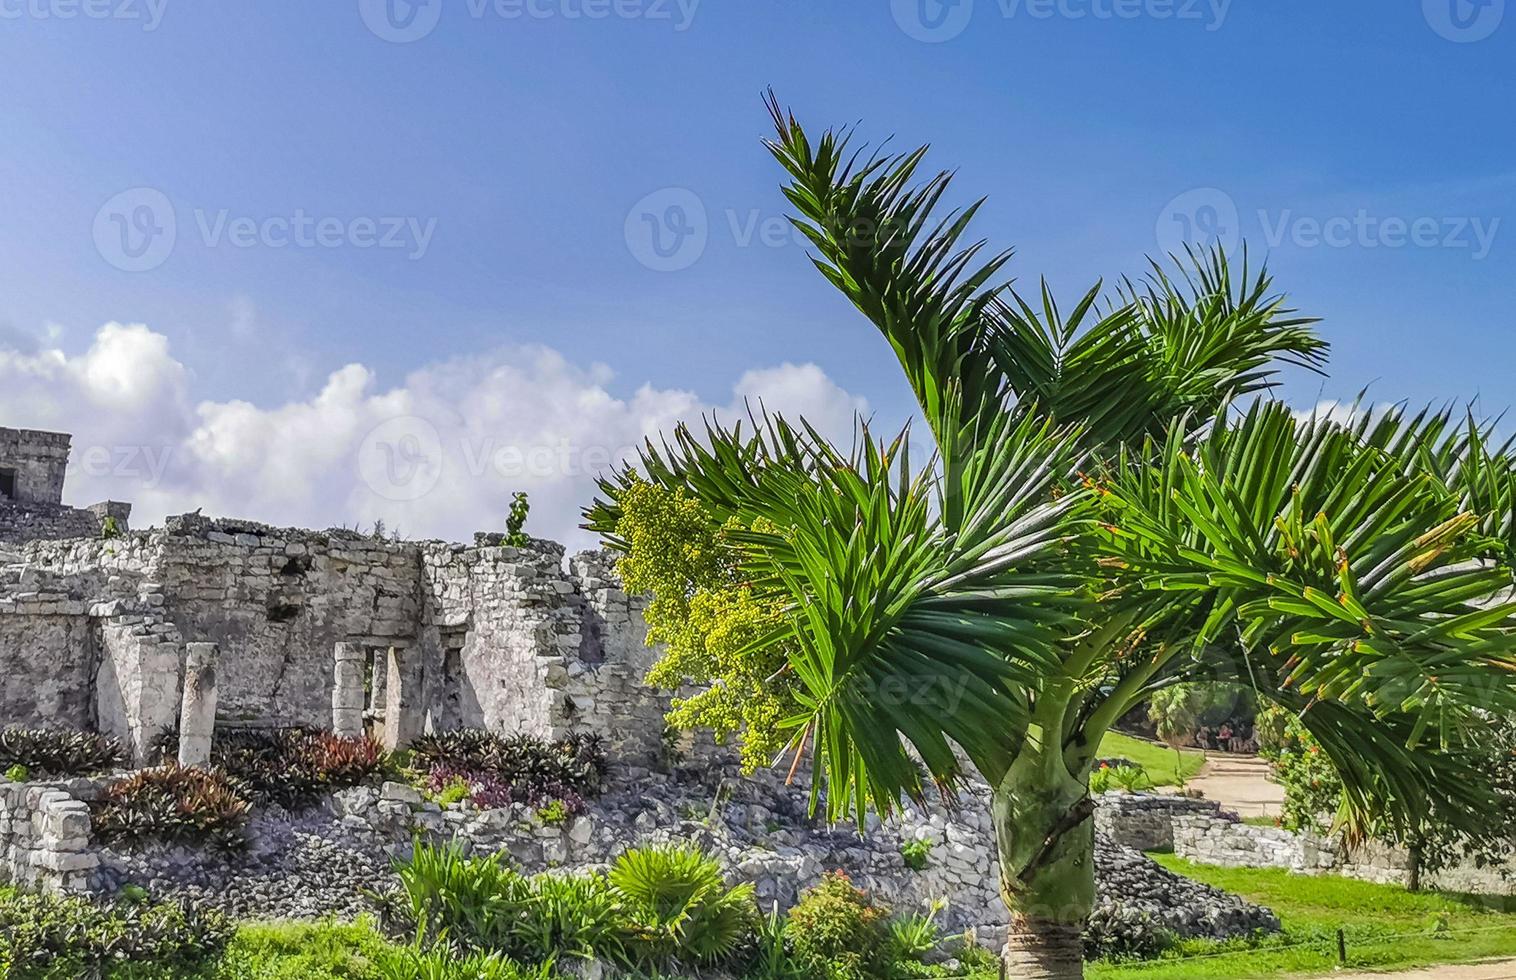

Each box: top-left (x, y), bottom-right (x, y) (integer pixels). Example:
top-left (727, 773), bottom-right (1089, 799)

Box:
top-left (787, 871), bottom-right (890, 980)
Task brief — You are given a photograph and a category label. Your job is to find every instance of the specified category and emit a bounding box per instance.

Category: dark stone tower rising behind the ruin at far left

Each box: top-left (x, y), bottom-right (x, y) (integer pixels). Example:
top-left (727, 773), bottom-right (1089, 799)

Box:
top-left (0, 428), bottom-right (132, 545)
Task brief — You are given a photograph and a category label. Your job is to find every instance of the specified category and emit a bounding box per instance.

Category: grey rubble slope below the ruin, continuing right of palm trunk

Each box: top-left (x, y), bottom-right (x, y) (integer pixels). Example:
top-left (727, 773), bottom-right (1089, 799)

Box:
top-left (97, 768), bottom-right (1280, 944)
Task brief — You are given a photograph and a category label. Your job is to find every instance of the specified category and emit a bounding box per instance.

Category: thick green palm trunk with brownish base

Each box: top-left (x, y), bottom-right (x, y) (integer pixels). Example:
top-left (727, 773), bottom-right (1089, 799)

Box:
top-left (991, 755), bottom-right (1095, 980)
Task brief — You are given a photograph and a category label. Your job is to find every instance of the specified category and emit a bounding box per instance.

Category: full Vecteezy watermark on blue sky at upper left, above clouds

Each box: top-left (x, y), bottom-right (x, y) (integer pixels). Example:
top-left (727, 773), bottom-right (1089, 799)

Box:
top-left (94, 187), bottom-right (437, 272)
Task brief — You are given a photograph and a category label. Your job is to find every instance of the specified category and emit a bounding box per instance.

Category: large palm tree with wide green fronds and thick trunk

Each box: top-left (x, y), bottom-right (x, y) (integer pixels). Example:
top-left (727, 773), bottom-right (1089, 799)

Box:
top-left (587, 96), bottom-right (1516, 977)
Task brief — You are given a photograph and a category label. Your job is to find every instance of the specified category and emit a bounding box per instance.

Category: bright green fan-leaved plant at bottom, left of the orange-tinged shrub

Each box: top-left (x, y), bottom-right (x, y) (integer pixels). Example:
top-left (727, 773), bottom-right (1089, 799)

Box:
top-left (609, 847), bottom-right (758, 963)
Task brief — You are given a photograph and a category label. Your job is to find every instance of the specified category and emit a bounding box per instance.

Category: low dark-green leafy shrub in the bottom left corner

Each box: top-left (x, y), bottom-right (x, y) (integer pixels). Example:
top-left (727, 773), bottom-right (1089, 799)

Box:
top-left (0, 895), bottom-right (235, 980)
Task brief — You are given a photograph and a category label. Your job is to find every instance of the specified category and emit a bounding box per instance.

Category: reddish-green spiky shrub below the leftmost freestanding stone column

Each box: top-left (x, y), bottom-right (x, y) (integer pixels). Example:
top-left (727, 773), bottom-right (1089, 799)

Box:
top-left (91, 765), bottom-right (250, 850)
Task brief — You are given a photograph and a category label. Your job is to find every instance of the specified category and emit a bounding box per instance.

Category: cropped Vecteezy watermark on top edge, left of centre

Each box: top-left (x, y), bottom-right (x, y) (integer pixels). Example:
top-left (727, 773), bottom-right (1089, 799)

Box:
top-left (358, 0), bottom-right (700, 44)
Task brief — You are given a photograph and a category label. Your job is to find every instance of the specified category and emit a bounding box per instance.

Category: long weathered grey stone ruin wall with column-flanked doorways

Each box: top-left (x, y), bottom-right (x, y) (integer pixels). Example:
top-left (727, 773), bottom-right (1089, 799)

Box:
top-left (0, 516), bottom-right (667, 759)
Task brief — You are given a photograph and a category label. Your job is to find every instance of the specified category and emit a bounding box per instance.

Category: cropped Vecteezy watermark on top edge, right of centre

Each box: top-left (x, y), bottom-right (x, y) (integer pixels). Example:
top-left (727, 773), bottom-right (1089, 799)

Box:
top-left (890, 0), bottom-right (1233, 44)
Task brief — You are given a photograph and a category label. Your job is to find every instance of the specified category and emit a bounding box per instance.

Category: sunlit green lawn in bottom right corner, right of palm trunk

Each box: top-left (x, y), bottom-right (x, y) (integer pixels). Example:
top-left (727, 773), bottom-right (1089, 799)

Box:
top-left (1087, 854), bottom-right (1516, 980)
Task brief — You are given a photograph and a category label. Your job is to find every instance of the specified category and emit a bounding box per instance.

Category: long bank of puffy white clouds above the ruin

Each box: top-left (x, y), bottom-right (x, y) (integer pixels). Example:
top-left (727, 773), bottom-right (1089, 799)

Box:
top-left (0, 323), bottom-right (869, 546)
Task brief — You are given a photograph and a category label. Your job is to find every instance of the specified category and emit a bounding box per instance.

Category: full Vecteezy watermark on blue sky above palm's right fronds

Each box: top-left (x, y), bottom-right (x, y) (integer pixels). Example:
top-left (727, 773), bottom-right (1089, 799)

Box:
top-left (1155, 187), bottom-right (1501, 261)
